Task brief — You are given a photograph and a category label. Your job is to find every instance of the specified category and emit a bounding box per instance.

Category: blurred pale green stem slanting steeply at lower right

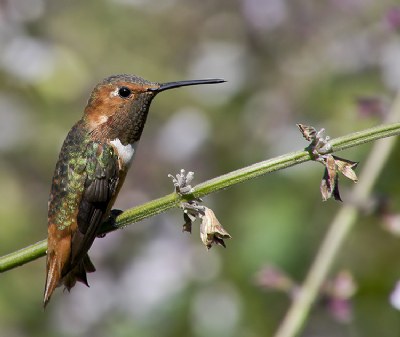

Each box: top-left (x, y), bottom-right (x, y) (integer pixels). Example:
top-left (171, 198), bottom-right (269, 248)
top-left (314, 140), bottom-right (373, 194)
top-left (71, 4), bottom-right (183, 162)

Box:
top-left (275, 95), bottom-right (400, 337)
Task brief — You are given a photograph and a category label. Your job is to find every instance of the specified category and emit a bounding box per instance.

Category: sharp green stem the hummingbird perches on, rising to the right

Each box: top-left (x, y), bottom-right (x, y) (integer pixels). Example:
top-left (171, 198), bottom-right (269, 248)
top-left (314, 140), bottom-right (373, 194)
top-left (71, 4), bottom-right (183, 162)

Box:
top-left (0, 119), bottom-right (400, 272)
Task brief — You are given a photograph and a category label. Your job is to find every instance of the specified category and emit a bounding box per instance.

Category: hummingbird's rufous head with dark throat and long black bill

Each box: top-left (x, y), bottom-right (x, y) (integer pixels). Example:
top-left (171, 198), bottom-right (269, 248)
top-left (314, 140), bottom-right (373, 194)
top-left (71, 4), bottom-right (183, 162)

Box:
top-left (84, 74), bottom-right (225, 141)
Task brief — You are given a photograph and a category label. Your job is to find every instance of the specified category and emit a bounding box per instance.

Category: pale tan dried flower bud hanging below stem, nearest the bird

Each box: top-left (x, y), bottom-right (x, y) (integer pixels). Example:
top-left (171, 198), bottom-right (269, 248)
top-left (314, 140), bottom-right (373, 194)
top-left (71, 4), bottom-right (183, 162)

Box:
top-left (200, 207), bottom-right (231, 249)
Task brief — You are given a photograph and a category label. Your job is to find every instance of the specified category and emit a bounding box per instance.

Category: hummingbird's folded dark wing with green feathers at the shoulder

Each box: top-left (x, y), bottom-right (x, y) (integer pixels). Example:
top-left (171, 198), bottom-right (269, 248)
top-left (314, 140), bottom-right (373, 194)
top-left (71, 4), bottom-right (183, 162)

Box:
top-left (71, 142), bottom-right (118, 267)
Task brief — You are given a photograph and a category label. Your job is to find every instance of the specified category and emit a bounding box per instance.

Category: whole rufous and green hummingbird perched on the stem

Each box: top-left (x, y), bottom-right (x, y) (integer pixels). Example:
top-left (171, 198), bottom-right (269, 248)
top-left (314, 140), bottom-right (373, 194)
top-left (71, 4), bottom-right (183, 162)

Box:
top-left (44, 74), bottom-right (225, 307)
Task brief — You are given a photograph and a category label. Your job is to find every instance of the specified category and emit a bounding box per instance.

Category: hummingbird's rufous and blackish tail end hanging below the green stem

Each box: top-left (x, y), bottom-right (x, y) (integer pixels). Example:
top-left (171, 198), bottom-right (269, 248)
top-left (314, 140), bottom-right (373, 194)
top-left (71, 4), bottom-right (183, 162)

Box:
top-left (43, 254), bottom-right (96, 308)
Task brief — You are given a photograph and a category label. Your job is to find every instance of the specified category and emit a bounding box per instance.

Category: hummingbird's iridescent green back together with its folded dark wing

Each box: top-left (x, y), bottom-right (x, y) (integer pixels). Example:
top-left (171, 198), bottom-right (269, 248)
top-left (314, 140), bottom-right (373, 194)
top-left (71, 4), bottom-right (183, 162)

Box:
top-left (48, 121), bottom-right (118, 274)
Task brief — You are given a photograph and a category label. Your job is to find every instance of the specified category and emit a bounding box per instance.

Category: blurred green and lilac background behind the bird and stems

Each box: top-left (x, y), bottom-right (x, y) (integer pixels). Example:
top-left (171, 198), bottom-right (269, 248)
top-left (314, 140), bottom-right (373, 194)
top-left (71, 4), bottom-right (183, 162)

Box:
top-left (0, 0), bottom-right (400, 337)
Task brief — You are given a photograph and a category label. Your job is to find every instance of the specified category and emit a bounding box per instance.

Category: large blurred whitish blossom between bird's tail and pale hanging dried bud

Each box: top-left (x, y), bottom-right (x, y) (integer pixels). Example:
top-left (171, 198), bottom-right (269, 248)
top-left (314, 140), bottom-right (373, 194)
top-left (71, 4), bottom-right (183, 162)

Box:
top-left (117, 231), bottom-right (189, 320)
